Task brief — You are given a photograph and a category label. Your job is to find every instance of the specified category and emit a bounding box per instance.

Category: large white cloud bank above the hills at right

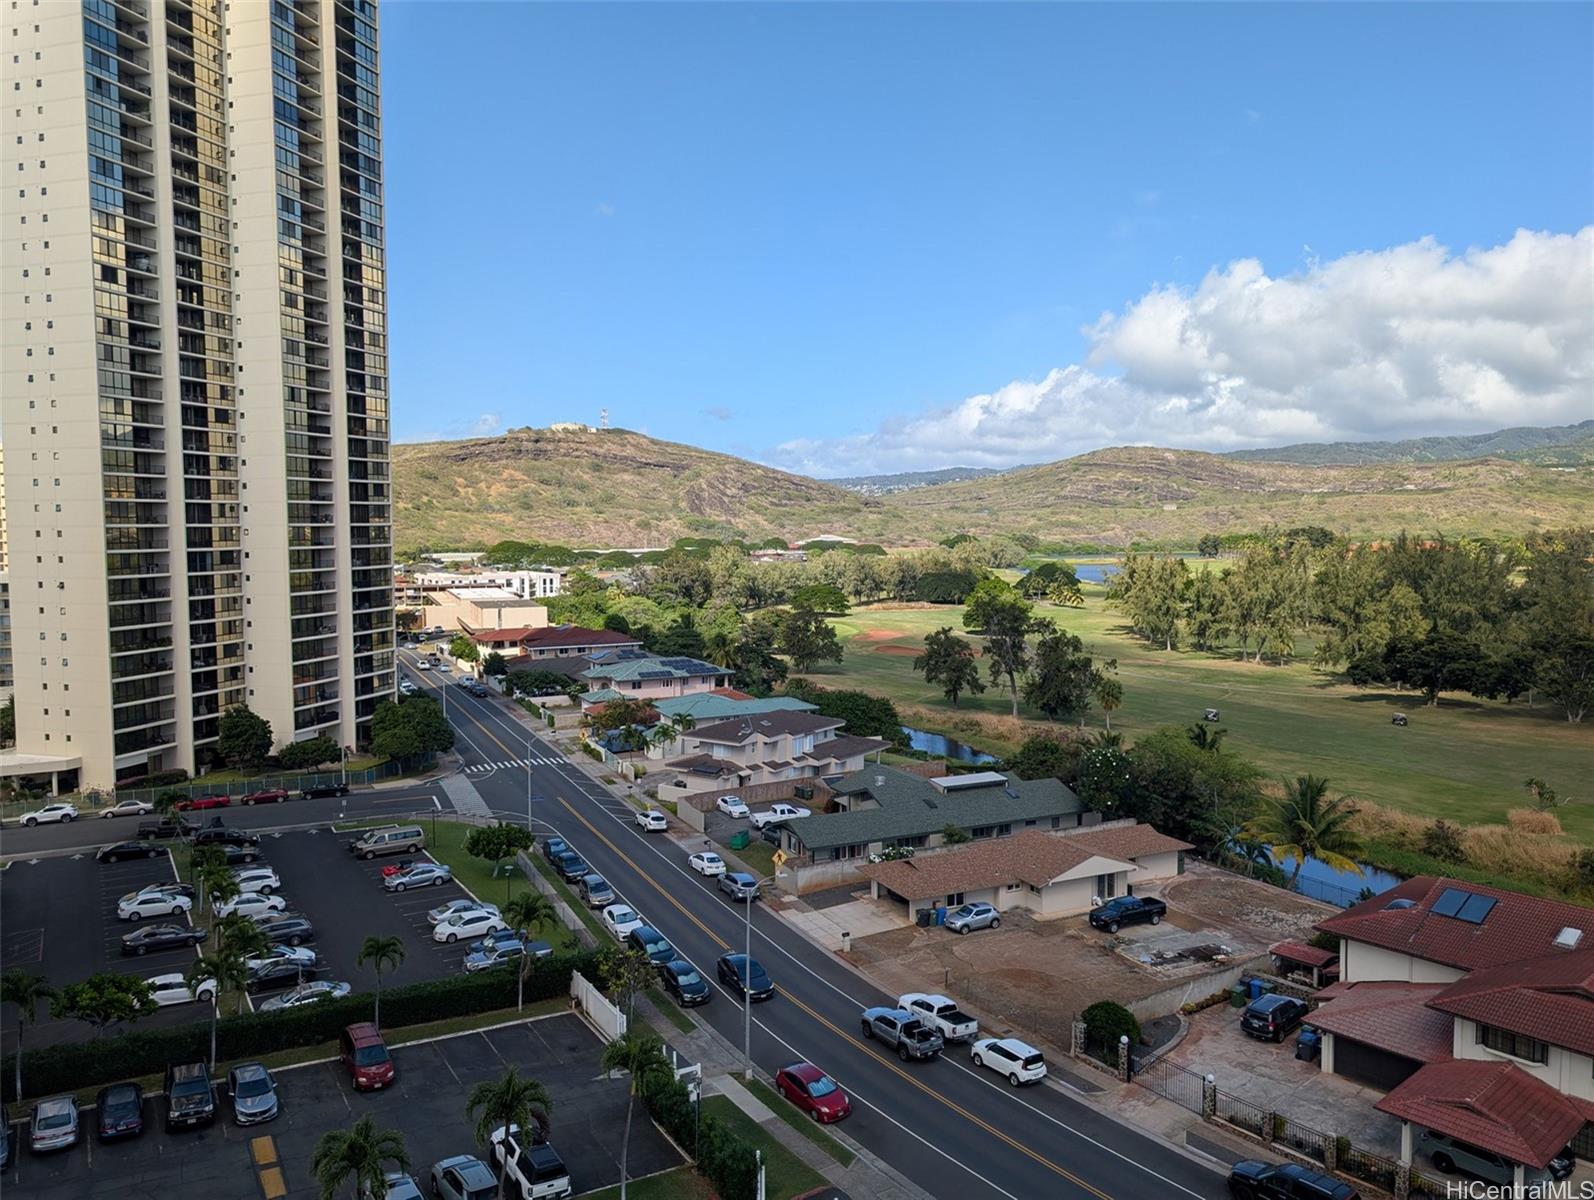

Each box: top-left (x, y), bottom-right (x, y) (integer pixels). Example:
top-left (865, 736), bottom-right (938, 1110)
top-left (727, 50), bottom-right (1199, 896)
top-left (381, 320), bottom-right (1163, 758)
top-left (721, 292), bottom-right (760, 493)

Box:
top-left (771, 226), bottom-right (1594, 475)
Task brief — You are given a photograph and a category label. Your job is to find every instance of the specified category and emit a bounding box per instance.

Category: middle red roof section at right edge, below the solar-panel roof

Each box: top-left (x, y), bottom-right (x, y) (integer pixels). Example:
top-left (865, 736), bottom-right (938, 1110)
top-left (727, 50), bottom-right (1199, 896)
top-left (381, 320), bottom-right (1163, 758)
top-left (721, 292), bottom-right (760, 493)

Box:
top-left (1430, 947), bottom-right (1594, 1057)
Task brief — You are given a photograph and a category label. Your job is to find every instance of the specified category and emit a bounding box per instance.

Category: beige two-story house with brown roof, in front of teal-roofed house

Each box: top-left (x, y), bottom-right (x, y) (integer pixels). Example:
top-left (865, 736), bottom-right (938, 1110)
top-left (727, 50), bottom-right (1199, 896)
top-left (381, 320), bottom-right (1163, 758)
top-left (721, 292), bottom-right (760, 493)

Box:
top-left (668, 709), bottom-right (889, 795)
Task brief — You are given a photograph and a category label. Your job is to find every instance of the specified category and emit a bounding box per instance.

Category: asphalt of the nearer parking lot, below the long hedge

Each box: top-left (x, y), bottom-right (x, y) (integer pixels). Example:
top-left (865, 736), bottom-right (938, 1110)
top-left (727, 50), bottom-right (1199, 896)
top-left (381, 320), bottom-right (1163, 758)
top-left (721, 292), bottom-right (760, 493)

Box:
top-left (5, 1015), bottom-right (681, 1200)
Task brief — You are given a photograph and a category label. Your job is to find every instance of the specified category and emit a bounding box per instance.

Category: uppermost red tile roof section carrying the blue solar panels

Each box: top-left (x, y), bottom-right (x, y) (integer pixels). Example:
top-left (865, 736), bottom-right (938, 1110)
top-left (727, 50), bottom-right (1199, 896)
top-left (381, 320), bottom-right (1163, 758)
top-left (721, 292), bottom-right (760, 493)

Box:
top-left (1317, 875), bottom-right (1594, 971)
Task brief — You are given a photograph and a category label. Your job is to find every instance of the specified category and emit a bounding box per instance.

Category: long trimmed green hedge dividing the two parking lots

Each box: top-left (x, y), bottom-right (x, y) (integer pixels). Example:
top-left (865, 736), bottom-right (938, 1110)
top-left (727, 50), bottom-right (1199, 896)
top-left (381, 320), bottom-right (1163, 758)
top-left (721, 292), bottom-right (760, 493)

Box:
top-left (0, 950), bottom-right (595, 1101)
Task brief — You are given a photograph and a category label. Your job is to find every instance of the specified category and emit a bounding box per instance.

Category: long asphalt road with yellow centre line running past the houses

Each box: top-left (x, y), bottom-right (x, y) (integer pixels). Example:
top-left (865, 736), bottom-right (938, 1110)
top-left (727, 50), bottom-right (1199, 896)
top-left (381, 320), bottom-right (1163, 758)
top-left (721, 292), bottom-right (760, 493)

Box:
top-left (395, 650), bottom-right (1226, 1200)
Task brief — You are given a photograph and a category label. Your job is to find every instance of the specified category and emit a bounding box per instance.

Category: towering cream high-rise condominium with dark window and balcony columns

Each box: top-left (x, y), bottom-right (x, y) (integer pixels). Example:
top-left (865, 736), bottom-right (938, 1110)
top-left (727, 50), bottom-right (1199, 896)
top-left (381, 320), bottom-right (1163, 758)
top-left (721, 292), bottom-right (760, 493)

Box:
top-left (0, 0), bottom-right (394, 786)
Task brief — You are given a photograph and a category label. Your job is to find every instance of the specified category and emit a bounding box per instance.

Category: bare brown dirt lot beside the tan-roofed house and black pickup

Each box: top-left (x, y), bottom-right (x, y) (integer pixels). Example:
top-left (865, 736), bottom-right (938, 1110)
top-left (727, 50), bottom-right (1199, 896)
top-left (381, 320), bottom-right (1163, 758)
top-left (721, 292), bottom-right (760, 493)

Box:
top-left (848, 864), bottom-right (1336, 1047)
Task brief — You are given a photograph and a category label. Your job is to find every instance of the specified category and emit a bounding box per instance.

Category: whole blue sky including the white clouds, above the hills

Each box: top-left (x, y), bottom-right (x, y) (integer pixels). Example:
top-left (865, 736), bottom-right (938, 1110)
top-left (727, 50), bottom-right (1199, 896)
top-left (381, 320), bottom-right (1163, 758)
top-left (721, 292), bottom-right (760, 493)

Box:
top-left (383, 0), bottom-right (1594, 473)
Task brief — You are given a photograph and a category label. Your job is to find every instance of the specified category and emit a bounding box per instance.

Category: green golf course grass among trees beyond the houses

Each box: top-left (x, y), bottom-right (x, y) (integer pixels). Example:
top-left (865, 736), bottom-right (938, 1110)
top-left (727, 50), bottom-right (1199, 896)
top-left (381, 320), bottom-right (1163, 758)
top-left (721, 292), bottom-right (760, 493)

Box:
top-left (810, 585), bottom-right (1594, 841)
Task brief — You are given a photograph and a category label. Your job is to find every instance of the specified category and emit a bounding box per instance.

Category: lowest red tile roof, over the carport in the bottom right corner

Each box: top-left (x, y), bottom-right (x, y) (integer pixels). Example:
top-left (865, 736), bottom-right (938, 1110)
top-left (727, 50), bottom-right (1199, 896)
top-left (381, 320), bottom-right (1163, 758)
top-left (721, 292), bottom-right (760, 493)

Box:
top-left (1374, 1058), bottom-right (1583, 1167)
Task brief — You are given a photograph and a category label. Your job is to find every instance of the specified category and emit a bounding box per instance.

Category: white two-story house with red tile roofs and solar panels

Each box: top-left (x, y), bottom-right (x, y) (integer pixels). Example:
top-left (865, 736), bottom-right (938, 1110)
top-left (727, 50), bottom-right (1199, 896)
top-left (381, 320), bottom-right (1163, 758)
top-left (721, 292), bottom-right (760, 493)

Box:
top-left (1312, 875), bottom-right (1594, 1182)
